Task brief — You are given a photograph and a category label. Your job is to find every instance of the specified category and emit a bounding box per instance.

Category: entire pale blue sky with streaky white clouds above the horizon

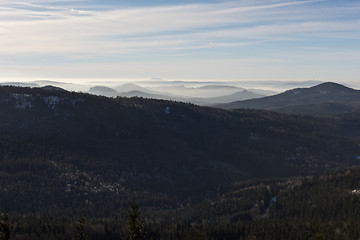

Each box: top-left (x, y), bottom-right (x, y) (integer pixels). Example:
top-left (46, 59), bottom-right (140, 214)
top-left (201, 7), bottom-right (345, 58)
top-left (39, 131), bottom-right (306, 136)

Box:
top-left (0, 0), bottom-right (360, 84)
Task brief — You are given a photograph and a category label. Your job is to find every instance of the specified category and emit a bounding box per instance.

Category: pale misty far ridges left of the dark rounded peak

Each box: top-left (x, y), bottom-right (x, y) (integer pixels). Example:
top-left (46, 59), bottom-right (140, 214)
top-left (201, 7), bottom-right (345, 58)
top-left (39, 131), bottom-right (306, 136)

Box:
top-left (1, 79), bottom-right (284, 105)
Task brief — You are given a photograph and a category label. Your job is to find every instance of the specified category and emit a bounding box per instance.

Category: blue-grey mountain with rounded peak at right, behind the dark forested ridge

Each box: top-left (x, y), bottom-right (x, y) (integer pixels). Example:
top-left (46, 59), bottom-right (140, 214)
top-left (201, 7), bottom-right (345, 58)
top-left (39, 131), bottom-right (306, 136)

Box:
top-left (216, 82), bottom-right (360, 115)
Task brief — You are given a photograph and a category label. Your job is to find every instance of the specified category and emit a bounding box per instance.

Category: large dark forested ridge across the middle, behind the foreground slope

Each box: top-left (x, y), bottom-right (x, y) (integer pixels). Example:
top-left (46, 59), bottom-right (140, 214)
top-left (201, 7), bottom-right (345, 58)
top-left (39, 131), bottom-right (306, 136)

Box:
top-left (0, 87), bottom-right (360, 216)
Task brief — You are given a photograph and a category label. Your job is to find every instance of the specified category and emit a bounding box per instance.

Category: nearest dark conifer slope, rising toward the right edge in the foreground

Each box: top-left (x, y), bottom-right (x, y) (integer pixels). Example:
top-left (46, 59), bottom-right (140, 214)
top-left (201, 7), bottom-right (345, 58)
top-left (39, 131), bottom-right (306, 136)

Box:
top-left (147, 167), bottom-right (360, 240)
